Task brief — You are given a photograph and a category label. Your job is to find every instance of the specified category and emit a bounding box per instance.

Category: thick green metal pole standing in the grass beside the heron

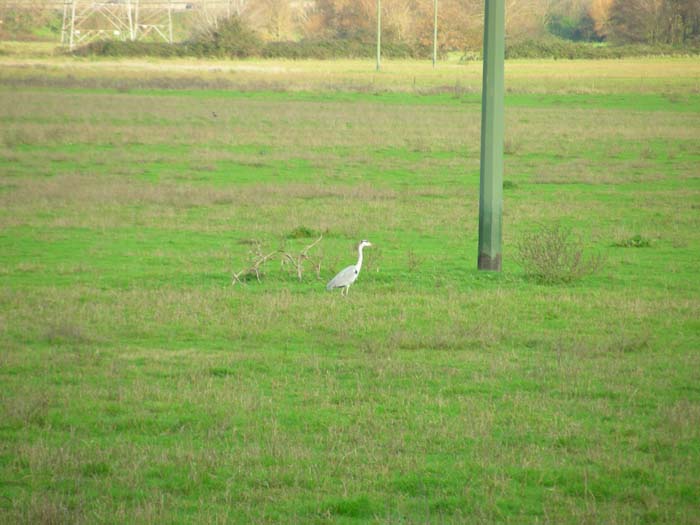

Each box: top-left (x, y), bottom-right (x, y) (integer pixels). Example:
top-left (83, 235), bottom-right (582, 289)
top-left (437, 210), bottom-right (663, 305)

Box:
top-left (478, 0), bottom-right (505, 271)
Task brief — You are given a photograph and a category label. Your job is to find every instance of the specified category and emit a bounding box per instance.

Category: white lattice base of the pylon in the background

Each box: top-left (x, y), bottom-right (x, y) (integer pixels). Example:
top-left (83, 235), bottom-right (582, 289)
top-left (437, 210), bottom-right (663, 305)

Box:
top-left (61, 0), bottom-right (175, 50)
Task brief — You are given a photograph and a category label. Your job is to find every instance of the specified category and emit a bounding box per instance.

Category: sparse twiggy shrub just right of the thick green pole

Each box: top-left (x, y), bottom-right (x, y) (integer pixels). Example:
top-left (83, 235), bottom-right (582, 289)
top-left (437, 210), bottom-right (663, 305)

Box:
top-left (517, 225), bottom-right (602, 284)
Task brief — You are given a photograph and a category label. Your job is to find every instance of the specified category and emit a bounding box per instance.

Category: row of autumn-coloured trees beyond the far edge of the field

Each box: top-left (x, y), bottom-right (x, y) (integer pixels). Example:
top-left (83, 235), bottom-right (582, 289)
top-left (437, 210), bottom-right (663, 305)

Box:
top-left (0, 0), bottom-right (700, 51)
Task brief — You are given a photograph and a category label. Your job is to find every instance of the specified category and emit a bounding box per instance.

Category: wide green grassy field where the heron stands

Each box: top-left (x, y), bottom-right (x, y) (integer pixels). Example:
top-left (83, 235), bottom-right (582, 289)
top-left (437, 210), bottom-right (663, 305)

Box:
top-left (0, 53), bottom-right (700, 524)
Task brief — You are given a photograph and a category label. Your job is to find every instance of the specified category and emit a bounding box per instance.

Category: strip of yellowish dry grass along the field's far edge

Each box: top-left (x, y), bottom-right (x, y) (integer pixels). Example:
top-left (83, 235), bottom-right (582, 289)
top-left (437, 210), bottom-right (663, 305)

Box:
top-left (0, 56), bottom-right (700, 94)
